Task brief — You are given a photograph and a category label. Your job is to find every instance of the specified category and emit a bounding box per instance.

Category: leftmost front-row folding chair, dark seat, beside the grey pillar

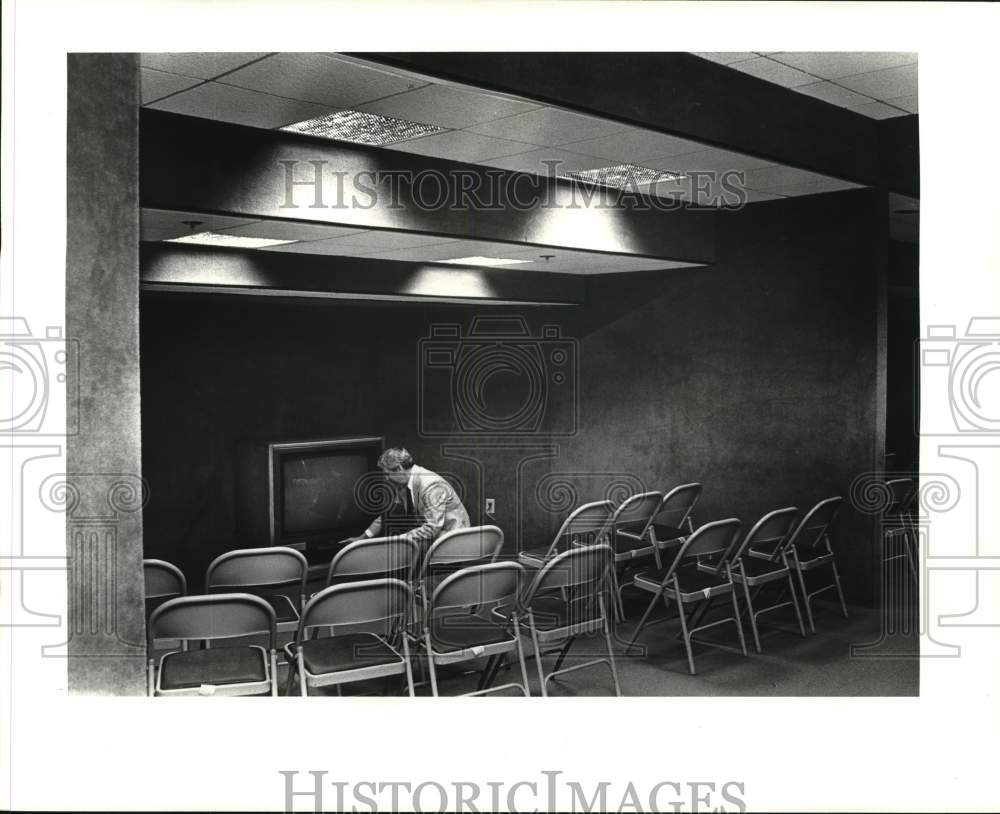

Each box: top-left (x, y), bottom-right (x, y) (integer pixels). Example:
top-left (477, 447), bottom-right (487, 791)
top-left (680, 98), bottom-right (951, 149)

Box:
top-left (146, 593), bottom-right (278, 696)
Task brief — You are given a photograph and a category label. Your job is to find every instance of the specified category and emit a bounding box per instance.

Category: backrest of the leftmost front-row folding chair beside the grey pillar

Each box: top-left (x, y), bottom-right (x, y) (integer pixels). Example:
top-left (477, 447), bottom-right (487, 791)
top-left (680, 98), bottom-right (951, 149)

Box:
top-left (146, 593), bottom-right (277, 652)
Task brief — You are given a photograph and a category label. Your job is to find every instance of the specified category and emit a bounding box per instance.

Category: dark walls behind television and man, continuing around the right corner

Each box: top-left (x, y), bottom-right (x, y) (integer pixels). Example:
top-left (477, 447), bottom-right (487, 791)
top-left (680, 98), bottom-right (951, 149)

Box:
top-left (142, 191), bottom-right (886, 599)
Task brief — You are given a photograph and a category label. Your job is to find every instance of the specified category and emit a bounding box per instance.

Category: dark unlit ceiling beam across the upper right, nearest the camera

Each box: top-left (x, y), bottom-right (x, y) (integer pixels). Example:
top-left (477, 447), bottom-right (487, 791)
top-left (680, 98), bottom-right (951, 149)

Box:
top-left (364, 52), bottom-right (918, 195)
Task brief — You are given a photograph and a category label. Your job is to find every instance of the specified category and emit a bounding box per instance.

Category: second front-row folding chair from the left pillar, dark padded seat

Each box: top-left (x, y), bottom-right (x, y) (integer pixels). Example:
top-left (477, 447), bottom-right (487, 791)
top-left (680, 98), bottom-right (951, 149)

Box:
top-left (285, 579), bottom-right (413, 697)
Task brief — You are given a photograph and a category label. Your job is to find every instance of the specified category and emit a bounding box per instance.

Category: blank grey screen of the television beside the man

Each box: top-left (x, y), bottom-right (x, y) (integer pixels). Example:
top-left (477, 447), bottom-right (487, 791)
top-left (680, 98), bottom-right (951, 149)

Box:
top-left (281, 452), bottom-right (371, 536)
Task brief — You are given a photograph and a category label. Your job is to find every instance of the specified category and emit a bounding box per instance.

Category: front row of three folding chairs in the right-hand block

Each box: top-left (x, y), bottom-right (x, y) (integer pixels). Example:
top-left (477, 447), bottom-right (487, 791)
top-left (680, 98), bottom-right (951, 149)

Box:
top-left (627, 497), bottom-right (847, 675)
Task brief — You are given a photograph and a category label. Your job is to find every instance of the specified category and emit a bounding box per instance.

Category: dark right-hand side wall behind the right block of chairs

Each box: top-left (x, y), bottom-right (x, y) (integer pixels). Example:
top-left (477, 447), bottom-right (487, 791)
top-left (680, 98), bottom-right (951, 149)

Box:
top-left (564, 191), bottom-right (887, 601)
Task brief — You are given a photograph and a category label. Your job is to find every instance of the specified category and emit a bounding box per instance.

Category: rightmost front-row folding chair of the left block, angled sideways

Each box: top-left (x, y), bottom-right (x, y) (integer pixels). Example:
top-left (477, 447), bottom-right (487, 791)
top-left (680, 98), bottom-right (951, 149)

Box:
top-left (504, 543), bottom-right (622, 697)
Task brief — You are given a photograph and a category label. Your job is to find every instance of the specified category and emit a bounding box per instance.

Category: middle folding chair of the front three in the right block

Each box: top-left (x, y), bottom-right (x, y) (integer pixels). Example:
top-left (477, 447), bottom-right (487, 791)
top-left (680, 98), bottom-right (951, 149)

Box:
top-left (716, 506), bottom-right (806, 653)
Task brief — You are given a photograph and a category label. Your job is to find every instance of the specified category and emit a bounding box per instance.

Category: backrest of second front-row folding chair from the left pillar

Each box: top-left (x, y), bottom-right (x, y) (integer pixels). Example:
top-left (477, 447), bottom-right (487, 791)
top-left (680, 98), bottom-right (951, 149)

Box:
top-left (297, 578), bottom-right (413, 641)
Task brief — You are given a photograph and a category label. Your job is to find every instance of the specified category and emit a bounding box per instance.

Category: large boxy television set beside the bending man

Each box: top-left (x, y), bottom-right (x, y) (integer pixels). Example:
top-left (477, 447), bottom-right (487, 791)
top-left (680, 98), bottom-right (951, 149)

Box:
top-left (237, 437), bottom-right (383, 550)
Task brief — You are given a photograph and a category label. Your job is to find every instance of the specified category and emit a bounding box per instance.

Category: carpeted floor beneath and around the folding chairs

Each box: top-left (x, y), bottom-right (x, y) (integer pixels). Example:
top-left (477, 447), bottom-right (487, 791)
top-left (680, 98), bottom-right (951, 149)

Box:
top-left (270, 592), bottom-right (920, 696)
